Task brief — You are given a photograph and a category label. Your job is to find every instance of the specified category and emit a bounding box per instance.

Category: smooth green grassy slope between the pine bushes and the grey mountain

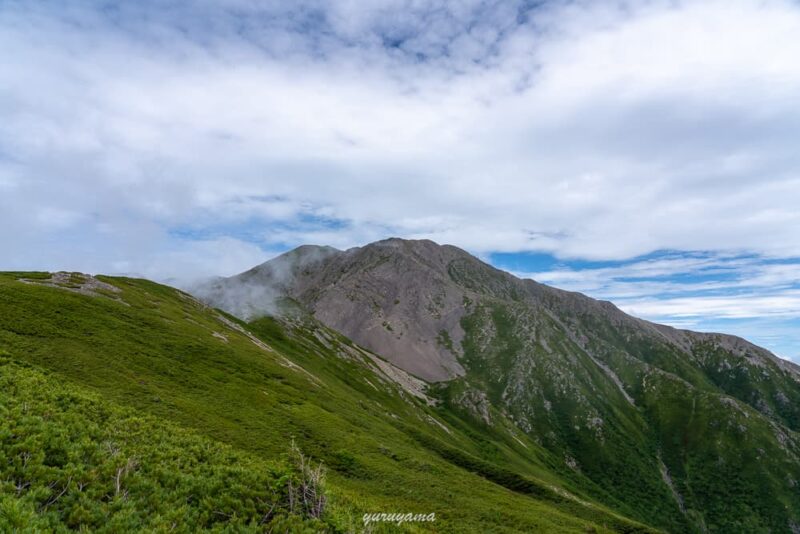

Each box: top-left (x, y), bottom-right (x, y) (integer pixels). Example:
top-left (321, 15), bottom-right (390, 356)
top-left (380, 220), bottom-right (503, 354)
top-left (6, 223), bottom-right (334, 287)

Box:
top-left (0, 274), bottom-right (648, 532)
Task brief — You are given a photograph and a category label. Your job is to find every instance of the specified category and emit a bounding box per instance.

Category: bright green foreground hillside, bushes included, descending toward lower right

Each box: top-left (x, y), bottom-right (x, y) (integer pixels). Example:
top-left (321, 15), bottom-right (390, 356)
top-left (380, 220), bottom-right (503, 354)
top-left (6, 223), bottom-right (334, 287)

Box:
top-left (0, 273), bottom-right (654, 532)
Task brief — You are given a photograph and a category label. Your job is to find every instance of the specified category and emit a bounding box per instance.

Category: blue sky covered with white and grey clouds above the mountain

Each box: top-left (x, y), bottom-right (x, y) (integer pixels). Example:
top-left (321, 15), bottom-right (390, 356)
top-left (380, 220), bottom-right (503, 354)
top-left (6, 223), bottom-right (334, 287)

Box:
top-left (0, 0), bottom-right (800, 361)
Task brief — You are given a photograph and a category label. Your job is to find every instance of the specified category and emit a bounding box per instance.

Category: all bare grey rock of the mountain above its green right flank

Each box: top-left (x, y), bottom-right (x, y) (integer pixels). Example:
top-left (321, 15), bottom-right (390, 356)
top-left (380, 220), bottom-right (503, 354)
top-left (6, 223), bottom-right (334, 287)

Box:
top-left (193, 238), bottom-right (800, 393)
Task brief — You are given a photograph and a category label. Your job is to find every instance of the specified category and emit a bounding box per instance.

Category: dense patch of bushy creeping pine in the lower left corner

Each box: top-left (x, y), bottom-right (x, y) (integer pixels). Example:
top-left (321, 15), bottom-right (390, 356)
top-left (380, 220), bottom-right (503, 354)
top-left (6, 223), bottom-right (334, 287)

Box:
top-left (0, 358), bottom-right (330, 532)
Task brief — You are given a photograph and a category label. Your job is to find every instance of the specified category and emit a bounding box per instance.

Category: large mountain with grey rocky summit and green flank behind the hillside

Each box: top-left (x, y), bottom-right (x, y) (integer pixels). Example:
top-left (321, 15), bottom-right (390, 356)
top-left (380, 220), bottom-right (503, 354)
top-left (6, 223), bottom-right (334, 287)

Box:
top-left (194, 239), bottom-right (800, 532)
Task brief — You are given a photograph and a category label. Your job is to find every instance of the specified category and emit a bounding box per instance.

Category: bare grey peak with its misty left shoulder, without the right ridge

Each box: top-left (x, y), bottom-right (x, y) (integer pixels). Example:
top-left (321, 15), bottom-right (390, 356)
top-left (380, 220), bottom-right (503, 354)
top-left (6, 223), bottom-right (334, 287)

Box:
top-left (194, 239), bottom-right (470, 382)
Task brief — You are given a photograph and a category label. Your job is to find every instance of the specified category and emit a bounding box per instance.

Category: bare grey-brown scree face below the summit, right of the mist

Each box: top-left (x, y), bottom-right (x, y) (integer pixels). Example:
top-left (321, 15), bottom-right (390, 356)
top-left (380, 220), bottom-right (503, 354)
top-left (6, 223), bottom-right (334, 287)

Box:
top-left (289, 240), bottom-right (465, 381)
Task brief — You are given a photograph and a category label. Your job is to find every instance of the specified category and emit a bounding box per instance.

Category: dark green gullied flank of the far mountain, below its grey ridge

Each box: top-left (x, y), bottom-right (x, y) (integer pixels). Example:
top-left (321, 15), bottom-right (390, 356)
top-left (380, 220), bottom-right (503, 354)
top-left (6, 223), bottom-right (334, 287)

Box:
top-left (450, 298), bottom-right (800, 533)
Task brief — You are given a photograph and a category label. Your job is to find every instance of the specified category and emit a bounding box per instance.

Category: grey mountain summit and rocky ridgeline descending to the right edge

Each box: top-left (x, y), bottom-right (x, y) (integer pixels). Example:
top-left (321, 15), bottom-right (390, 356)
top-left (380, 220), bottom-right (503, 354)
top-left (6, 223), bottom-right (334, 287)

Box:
top-left (193, 237), bottom-right (800, 382)
